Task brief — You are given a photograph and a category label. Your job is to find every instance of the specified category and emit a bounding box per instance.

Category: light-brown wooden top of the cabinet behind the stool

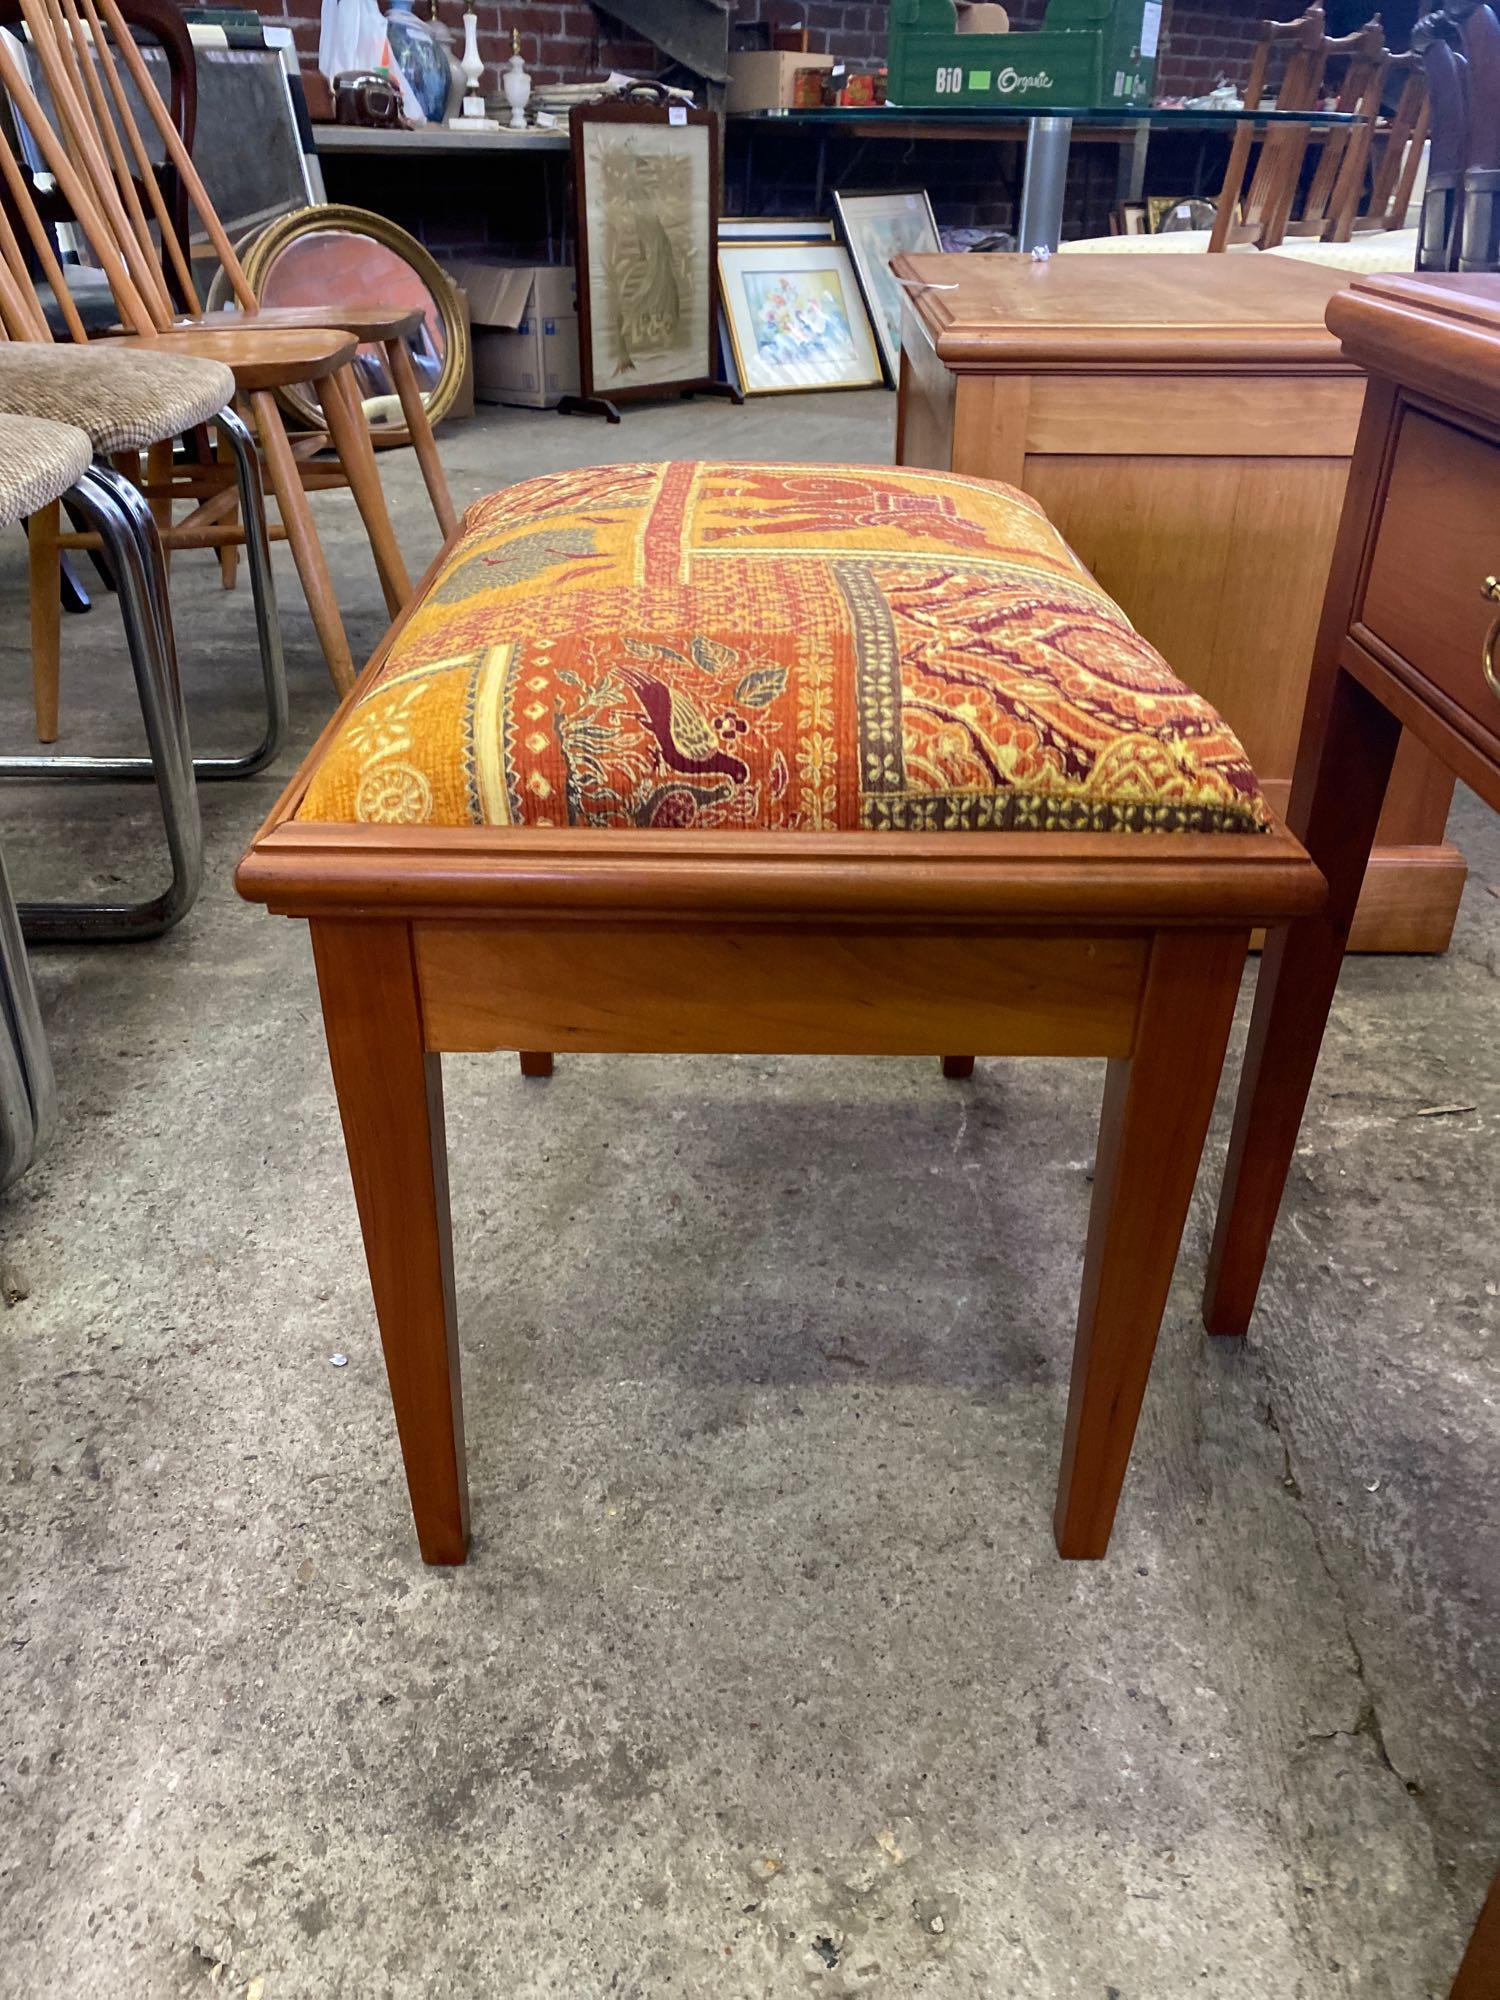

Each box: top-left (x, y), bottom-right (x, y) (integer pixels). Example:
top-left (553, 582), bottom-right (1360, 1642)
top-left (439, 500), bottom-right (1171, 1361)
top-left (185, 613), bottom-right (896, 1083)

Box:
top-left (892, 252), bottom-right (1352, 374)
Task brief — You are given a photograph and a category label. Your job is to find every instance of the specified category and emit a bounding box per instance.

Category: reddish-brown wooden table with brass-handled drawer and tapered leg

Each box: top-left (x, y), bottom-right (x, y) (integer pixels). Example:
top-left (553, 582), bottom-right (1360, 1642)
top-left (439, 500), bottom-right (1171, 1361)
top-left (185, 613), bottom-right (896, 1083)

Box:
top-left (1204, 274), bottom-right (1500, 1334)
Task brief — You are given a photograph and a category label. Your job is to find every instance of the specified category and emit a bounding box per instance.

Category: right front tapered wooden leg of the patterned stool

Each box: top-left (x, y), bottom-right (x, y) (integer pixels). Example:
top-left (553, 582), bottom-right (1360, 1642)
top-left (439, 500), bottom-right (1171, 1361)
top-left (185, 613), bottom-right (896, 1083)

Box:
top-left (1054, 930), bottom-right (1250, 1556)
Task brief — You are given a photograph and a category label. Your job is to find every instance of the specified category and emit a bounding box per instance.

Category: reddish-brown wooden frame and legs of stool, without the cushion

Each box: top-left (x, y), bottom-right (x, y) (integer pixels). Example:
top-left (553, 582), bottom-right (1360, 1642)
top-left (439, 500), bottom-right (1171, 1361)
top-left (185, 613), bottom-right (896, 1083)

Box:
top-left (238, 556), bottom-right (1324, 1562)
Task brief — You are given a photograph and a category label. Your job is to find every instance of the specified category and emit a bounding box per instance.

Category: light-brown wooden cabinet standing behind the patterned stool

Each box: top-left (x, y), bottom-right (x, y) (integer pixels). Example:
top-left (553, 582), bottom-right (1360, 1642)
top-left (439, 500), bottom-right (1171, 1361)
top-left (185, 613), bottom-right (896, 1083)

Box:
top-left (894, 254), bottom-right (1472, 952)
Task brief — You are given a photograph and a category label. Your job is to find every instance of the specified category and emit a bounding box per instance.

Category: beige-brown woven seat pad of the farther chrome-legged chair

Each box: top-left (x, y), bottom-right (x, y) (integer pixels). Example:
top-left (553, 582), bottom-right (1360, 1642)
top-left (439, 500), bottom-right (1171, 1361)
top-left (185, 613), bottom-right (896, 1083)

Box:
top-left (0, 342), bottom-right (234, 456)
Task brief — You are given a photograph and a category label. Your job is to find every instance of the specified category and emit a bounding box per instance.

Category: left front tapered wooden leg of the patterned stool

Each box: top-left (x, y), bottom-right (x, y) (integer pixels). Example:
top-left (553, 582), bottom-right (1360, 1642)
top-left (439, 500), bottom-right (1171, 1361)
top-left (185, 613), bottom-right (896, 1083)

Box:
top-left (312, 918), bottom-right (468, 1562)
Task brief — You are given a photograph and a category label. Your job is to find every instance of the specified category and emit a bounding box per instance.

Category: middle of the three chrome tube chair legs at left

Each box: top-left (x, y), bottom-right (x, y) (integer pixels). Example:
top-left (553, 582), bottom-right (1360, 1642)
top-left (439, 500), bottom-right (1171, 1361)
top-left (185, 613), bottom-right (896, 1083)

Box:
top-left (0, 466), bottom-right (204, 944)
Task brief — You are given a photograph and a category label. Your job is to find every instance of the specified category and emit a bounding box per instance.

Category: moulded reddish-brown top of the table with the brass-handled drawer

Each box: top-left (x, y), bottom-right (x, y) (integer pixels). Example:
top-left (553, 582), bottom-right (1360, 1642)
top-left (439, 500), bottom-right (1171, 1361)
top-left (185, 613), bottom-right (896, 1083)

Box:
top-left (1328, 272), bottom-right (1500, 424)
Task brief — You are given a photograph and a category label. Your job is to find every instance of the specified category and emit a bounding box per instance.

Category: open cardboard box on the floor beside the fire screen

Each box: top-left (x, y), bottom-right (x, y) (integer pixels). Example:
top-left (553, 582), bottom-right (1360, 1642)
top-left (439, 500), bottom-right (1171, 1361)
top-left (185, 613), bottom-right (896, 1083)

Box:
top-left (444, 258), bottom-right (578, 410)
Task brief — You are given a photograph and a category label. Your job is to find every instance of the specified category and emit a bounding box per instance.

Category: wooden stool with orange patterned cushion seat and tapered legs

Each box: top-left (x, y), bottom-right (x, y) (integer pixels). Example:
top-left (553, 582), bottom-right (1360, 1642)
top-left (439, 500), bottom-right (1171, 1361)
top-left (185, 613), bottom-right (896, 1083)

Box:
top-left (238, 464), bottom-right (1322, 1562)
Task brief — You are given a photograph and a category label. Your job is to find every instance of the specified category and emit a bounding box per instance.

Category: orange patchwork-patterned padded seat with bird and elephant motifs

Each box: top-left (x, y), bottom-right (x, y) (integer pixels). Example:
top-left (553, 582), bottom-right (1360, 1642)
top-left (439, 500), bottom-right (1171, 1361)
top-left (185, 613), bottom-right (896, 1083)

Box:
top-left (298, 464), bottom-right (1268, 832)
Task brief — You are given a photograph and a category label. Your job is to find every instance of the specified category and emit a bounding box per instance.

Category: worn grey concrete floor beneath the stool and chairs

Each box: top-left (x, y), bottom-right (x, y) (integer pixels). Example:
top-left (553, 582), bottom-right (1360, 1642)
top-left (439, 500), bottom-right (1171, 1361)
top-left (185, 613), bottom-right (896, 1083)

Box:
top-left (0, 394), bottom-right (1500, 2000)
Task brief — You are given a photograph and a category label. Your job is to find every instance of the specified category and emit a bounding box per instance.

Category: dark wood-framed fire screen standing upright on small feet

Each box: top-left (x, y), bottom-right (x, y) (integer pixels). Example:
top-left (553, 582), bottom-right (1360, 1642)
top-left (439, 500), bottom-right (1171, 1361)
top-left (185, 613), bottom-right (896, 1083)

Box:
top-left (562, 104), bottom-right (724, 420)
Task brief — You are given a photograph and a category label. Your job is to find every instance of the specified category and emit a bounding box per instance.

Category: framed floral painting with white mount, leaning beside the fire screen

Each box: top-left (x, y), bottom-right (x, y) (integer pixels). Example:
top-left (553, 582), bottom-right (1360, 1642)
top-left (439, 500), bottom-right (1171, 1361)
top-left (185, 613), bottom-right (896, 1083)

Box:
top-left (718, 244), bottom-right (884, 396)
